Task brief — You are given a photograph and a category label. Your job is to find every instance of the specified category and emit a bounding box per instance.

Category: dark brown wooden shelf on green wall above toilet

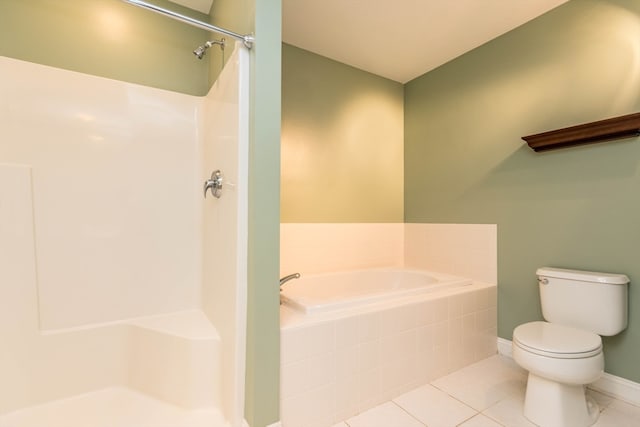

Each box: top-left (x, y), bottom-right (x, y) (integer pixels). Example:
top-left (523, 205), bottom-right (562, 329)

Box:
top-left (522, 113), bottom-right (640, 151)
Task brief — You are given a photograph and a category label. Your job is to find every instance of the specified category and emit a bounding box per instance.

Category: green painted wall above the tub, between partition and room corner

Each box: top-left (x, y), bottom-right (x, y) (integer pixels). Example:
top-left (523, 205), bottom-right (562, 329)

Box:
top-left (280, 44), bottom-right (404, 222)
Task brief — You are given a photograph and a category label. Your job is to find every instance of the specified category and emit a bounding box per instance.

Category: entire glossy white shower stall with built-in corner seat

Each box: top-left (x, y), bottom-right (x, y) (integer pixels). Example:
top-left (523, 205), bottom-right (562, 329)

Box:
top-left (0, 43), bottom-right (249, 427)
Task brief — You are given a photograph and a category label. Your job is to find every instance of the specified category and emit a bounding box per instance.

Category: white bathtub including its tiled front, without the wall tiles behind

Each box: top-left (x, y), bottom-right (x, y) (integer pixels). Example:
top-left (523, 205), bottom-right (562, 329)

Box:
top-left (280, 269), bottom-right (497, 426)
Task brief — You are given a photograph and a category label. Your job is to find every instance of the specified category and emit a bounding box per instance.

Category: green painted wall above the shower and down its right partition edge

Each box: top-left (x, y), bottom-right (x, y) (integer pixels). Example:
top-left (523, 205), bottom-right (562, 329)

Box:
top-left (0, 0), bottom-right (281, 427)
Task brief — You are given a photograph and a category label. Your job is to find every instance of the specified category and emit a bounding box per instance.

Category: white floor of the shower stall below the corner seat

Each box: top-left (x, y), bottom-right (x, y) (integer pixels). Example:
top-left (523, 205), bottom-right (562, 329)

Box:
top-left (0, 387), bottom-right (228, 427)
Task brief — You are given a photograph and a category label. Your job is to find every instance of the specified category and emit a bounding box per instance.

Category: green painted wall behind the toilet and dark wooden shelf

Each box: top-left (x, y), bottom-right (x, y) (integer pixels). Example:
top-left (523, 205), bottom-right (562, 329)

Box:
top-left (405, 0), bottom-right (640, 381)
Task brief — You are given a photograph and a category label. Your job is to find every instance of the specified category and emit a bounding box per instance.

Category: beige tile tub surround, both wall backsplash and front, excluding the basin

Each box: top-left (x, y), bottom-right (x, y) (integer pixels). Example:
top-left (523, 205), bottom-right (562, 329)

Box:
top-left (280, 224), bottom-right (497, 427)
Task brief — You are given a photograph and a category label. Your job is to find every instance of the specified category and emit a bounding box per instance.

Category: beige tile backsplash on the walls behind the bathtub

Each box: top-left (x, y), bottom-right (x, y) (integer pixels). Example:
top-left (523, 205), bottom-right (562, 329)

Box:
top-left (280, 223), bottom-right (498, 283)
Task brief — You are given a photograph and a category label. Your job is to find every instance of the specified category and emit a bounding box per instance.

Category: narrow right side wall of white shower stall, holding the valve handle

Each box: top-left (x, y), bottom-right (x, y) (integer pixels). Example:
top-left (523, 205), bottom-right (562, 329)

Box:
top-left (201, 42), bottom-right (249, 426)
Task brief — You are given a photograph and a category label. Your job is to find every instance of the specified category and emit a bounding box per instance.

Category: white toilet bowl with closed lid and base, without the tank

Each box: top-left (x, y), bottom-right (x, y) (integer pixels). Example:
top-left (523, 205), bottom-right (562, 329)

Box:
top-left (513, 322), bottom-right (604, 427)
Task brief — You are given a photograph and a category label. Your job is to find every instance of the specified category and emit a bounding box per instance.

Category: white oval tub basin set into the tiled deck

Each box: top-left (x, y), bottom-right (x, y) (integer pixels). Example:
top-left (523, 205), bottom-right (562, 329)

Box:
top-left (281, 269), bottom-right (472, 314)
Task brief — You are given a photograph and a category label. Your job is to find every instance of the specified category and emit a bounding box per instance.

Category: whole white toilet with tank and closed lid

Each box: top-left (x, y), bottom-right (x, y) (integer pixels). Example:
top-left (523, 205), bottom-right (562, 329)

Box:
top-left (512, 267), bottom-right (629, 427)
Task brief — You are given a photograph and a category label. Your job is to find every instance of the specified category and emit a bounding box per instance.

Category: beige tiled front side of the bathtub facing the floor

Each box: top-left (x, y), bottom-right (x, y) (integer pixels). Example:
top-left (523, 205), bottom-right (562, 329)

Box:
top-left (281, 284), bottom-right (497, 427)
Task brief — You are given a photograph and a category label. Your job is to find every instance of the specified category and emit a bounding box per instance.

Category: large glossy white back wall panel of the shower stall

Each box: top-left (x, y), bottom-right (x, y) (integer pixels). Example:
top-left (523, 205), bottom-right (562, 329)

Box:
top-left (0, 57), bottom-right (202, 330)
